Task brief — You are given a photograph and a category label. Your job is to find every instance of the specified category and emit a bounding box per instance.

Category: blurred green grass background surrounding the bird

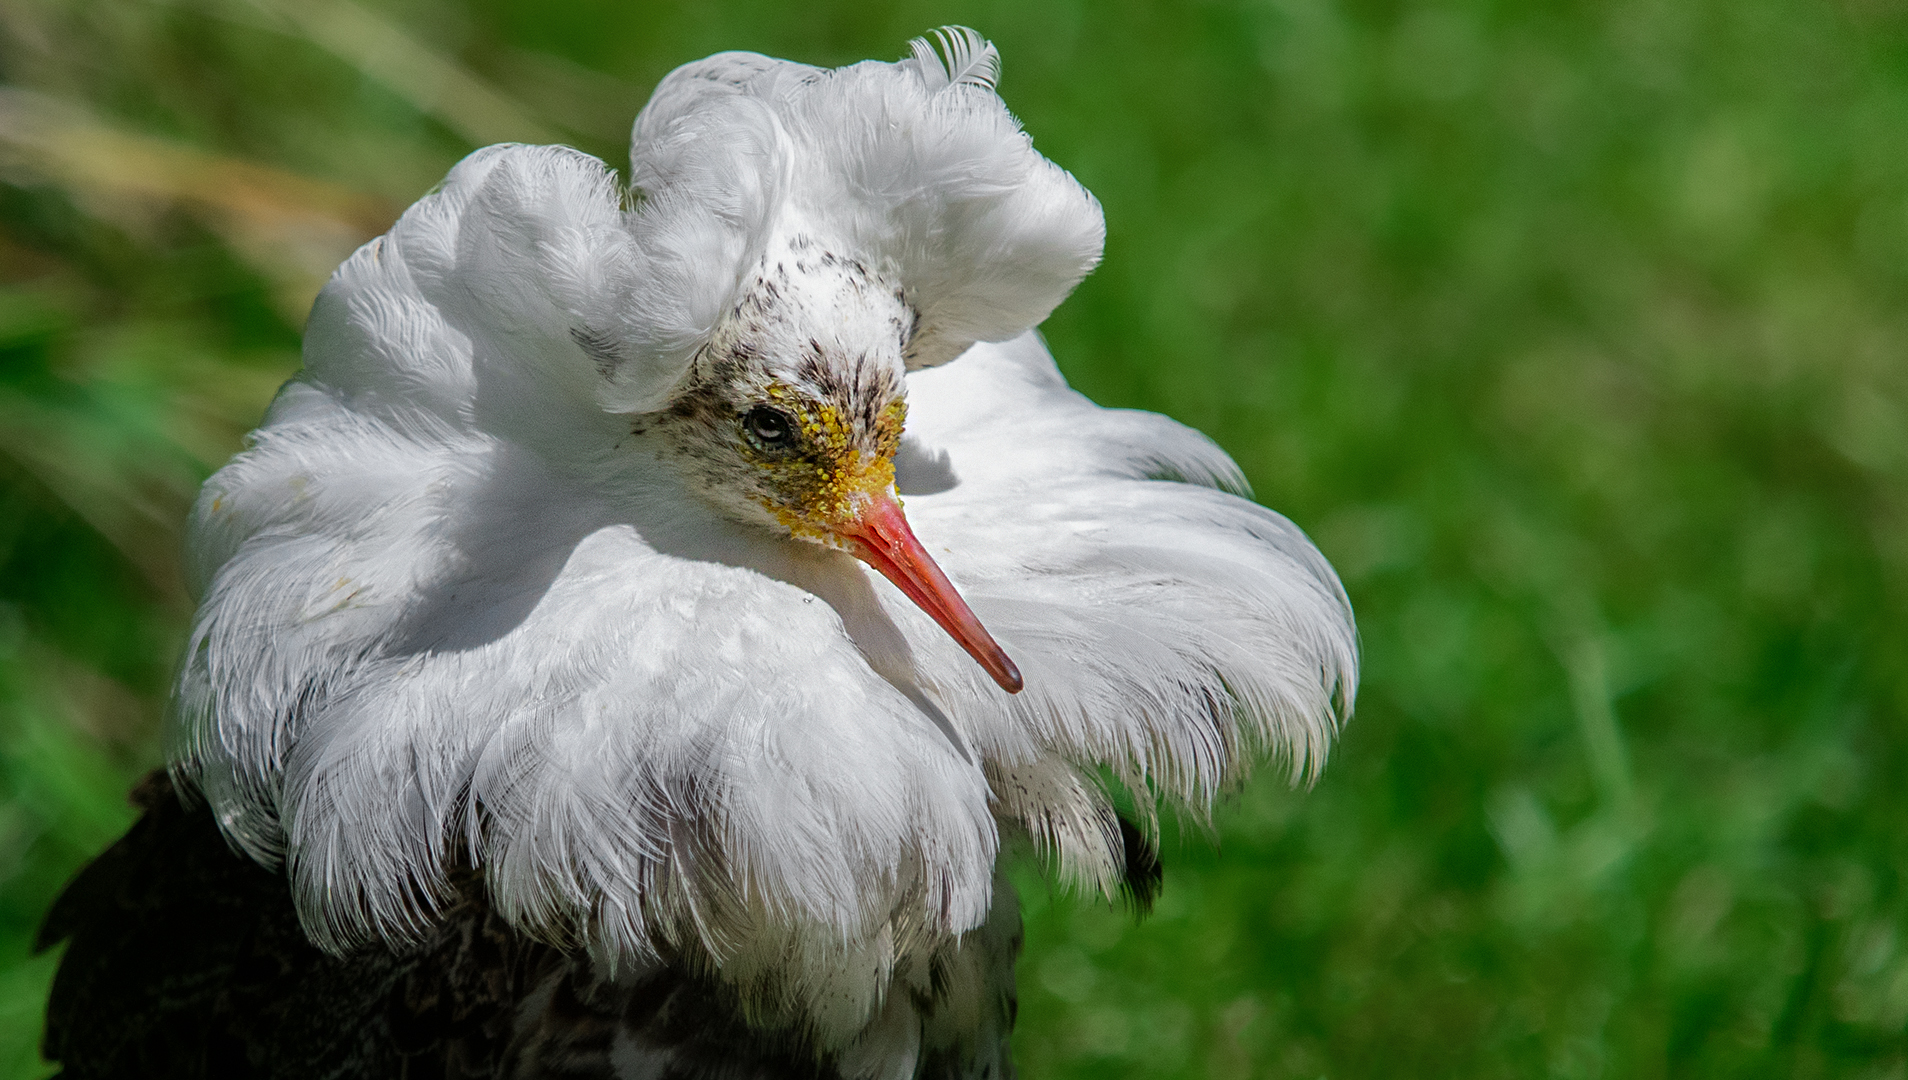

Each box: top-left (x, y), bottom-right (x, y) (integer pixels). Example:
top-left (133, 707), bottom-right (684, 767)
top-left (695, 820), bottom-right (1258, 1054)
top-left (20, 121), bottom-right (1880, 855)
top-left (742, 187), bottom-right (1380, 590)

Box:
top-left (0, 0), bottom-right (1908, 1078)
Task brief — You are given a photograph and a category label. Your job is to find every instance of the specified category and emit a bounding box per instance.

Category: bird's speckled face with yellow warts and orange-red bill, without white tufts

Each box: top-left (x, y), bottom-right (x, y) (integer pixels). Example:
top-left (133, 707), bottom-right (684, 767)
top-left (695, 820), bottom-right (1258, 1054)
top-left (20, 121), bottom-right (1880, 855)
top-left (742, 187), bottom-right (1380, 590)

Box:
top-left (639, 229), bottom-right (1021, 693)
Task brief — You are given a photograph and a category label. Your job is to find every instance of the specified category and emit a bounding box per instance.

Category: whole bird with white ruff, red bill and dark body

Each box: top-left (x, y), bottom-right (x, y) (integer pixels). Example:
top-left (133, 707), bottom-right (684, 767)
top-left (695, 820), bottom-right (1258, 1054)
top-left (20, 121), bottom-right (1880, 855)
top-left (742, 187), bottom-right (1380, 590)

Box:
top-left (40, 27), bottom-right (1358, 1080)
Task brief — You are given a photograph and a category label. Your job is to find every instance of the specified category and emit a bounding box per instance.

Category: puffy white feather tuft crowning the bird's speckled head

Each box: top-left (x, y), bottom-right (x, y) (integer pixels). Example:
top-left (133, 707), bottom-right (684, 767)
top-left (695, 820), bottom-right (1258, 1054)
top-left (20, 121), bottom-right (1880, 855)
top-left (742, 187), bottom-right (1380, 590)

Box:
top-left (618, 27), bottom-right (1107, 394)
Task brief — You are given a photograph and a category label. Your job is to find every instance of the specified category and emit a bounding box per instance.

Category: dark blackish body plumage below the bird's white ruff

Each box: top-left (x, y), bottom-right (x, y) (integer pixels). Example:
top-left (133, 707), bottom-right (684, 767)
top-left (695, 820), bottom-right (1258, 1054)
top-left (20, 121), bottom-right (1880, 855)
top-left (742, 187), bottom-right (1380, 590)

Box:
top-left (38, 773), bottom-right (1019, 1080)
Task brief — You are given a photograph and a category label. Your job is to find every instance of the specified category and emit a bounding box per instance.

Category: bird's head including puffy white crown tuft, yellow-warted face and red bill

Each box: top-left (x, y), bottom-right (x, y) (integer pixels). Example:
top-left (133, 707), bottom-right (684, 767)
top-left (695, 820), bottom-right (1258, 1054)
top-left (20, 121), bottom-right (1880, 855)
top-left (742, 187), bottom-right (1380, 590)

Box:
top-left (553, 27), bottom-right (1105, 693)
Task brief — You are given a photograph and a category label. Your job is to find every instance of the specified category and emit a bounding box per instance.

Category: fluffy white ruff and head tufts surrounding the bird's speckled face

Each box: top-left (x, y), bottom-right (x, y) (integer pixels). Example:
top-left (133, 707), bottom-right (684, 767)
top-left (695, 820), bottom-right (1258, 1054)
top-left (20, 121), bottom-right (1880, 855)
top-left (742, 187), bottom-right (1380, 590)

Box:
top-left (172, 27), bottom-right (1357, 1044)
